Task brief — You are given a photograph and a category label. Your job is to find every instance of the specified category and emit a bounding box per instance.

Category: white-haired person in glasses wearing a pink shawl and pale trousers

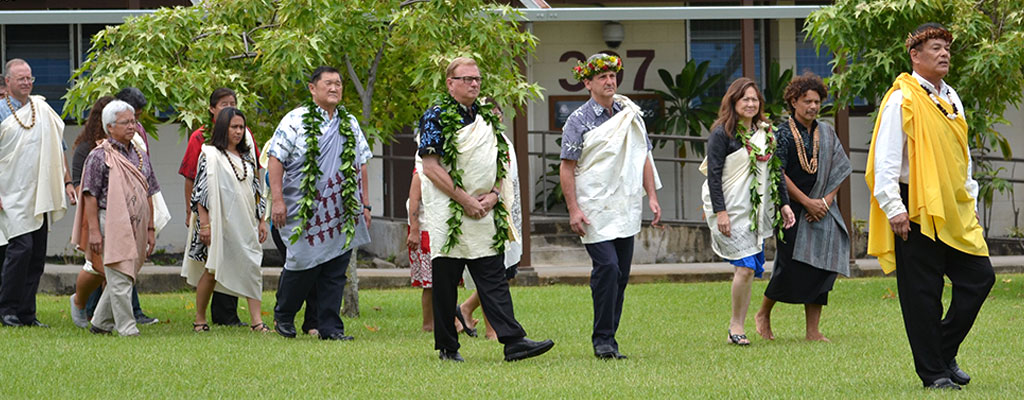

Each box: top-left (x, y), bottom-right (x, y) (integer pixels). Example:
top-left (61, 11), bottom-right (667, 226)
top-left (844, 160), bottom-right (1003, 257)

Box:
top-left (72, 100), bottom-right (160, 337)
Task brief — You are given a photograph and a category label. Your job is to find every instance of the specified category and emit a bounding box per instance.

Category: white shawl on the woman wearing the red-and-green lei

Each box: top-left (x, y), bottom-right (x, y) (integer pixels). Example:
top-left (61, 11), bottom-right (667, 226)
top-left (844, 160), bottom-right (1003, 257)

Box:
top-left (700, 128), bottom-right (775, 260)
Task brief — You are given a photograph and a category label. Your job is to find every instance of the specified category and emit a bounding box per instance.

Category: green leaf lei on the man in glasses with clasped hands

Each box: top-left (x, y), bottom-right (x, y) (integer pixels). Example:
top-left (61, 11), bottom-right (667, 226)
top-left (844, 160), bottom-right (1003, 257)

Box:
top-left (438, 96), bottom-right (509, 253)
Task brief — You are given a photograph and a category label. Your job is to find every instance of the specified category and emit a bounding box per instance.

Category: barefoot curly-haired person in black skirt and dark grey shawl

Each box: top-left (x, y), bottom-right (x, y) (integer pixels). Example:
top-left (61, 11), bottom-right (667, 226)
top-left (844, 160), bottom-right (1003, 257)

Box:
top-left (755, 73), bottom-right (851, 342)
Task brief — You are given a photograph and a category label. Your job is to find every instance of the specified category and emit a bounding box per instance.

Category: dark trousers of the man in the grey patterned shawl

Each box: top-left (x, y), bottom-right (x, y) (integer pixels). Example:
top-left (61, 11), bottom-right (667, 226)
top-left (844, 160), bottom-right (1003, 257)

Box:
top-left (273, 251), bottom-right (350, 338)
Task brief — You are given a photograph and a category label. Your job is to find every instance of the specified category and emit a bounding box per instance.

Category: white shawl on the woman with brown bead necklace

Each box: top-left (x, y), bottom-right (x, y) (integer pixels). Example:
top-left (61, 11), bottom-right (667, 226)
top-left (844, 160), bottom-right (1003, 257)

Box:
top-left (181, 144), bottom-right (263, 299)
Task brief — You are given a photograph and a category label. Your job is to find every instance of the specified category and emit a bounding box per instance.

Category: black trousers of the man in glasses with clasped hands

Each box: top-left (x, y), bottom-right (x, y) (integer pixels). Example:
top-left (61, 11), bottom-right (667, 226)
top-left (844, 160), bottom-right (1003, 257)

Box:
top-left (431, 254), bottom-right (526, 351)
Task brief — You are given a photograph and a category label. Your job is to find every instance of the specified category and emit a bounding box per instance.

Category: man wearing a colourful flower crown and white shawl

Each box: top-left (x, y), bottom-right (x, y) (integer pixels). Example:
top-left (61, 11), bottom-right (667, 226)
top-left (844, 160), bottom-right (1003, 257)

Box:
top-left (559, 53), bottom-right (662, 360)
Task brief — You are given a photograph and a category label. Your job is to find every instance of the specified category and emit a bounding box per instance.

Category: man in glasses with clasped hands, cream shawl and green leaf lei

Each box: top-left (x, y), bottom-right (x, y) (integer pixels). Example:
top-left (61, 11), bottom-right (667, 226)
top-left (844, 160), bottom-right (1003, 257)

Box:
top-left (418, 57), bottom-right (555, 362)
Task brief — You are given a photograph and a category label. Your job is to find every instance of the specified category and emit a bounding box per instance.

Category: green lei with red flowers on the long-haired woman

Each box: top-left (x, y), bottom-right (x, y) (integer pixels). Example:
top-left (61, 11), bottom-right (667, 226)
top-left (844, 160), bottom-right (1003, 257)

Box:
top-left (736, 122), bottom-right (783, 240)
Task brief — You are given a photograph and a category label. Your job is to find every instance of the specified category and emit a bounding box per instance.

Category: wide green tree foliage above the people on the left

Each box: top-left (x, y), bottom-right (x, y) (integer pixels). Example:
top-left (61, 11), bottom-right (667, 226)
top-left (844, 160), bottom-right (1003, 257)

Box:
top-left (63, 0), bottom-right (542, 141)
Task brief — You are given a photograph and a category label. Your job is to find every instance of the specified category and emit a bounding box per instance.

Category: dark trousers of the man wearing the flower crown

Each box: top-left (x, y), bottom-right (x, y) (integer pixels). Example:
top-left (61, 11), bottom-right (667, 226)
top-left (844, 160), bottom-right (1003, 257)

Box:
top-left (586, 237), bottom-right (633, 350)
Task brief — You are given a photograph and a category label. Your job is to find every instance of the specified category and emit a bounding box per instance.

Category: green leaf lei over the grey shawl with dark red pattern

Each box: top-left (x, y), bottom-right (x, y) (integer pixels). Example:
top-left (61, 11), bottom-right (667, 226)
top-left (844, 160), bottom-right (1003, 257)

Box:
top-left (289, 99), bottom-right (359, 248)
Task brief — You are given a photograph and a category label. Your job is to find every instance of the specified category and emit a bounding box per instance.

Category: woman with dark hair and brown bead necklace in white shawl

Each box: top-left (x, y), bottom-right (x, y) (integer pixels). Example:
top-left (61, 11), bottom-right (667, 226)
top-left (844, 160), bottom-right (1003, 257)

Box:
top-left (181, 107), bottom-right (270, 332)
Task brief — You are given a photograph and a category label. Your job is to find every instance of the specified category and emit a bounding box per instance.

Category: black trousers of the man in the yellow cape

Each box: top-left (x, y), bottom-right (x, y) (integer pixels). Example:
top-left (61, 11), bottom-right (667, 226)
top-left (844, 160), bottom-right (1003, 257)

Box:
top-left (896, 185), bottom-right (995, 385)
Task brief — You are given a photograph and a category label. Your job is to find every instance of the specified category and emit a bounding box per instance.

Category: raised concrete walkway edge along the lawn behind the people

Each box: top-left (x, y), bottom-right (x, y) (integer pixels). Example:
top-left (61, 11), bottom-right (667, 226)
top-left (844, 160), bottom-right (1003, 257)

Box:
top-left (39, 256), bottom-right (1024, 295)
